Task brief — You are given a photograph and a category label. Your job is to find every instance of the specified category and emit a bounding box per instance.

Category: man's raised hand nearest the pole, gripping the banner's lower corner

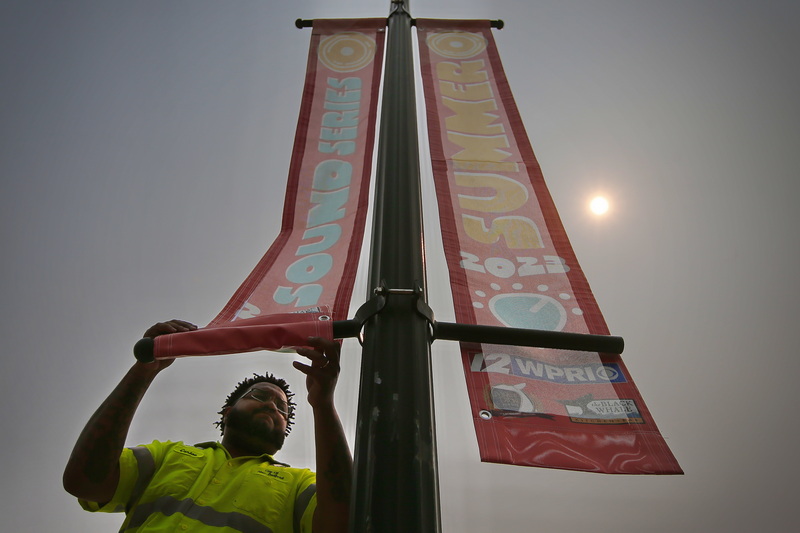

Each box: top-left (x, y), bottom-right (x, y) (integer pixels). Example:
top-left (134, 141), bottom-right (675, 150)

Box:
top-left (293, 337), bottom-right (341, 408)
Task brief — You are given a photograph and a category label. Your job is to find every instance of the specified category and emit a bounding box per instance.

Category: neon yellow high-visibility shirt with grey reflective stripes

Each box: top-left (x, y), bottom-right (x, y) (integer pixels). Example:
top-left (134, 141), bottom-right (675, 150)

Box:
top-left (79, 441), bottom-right (317, 533)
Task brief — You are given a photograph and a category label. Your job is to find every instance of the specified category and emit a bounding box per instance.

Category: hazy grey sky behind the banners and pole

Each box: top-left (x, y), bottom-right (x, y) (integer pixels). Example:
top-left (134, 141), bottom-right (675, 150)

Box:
top-left (0, 0), bottom-right (800, 533)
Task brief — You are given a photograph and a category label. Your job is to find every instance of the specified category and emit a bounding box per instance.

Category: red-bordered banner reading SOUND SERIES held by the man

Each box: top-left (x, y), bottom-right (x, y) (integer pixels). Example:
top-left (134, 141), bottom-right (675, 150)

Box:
top-left (155, 19), bottom-right (386, 358)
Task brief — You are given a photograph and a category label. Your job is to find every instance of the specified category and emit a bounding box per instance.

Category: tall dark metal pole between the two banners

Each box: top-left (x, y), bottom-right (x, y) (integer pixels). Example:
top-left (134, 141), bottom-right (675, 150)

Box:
top-left (351, 0), bottom-right (441, 533)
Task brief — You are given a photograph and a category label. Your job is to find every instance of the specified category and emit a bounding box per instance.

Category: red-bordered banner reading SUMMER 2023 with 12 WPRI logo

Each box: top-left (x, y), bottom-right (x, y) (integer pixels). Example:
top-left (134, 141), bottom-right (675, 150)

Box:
top-left (417, 19), bottom-right (681, 474)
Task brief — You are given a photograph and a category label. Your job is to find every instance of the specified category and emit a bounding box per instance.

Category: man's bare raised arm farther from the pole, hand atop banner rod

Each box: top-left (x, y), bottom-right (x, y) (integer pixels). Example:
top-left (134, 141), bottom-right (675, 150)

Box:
top-left (63, 320), bottom-right (197, 503)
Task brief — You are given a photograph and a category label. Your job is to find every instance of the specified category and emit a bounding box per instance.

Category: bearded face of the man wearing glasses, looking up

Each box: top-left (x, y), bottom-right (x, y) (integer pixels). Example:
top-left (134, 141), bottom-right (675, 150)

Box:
top-left (225, 383), bottom-right (288, 453)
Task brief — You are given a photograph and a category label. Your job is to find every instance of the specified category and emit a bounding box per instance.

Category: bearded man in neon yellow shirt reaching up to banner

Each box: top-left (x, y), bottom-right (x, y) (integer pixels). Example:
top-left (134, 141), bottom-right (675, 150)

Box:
top-left (64, 320), bottom-right (352, 533)
